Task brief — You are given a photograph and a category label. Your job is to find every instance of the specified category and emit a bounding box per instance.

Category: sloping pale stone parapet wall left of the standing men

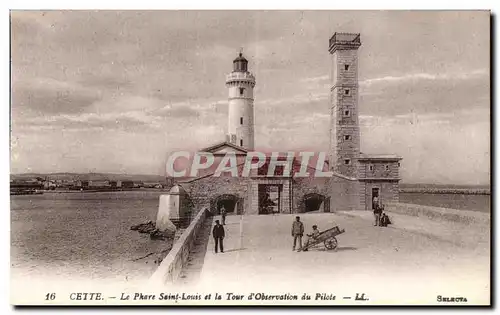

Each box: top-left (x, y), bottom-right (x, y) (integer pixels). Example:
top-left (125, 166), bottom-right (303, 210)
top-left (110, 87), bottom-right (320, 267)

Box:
top-left (150, 208), bottom-right (209, 286)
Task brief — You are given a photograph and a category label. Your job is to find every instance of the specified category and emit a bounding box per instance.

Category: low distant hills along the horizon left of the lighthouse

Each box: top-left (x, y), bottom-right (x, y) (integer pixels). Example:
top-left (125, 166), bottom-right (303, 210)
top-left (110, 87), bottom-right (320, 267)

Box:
top-left (10, 173), bottom-right (165, 182)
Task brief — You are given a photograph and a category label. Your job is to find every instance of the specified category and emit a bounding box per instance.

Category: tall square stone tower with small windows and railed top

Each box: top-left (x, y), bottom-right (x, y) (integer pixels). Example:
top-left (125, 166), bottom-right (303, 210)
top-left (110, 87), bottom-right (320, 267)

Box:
top-left (328, 33), bottom-right (361, 177)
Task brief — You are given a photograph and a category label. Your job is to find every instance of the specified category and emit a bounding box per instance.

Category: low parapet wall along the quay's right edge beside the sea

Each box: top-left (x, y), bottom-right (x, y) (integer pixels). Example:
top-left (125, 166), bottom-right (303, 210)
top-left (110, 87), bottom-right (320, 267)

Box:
top-left (384, 202), bottom-right (490, 225)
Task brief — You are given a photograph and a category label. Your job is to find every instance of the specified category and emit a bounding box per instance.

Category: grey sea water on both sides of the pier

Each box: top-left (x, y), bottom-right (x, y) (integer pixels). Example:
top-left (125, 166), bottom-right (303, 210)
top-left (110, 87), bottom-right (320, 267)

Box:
top-left (10, 191), bottom-right (490, 288)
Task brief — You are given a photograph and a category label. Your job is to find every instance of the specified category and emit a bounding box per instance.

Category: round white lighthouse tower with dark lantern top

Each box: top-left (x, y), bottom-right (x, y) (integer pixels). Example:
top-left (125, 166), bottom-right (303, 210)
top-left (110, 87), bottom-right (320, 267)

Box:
top-left (226, 53), bottom-right (255, 151)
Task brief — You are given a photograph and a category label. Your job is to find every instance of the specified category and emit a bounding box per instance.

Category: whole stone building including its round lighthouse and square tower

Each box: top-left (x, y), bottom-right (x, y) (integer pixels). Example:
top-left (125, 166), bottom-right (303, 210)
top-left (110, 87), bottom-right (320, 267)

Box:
top-left (163, 33), bottom-right (401, 221)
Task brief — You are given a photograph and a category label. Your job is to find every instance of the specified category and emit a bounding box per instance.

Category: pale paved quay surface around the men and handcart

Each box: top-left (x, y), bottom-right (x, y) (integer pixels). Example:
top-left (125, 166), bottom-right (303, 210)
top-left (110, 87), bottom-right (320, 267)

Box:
top-left (175, 213), bottom-right (490, 304)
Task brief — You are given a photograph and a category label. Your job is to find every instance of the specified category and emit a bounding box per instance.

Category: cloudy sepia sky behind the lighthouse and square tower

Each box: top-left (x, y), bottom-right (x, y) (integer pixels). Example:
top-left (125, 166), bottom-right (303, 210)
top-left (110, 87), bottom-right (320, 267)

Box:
top-left (11, 11), bottom-right (490, 185)
